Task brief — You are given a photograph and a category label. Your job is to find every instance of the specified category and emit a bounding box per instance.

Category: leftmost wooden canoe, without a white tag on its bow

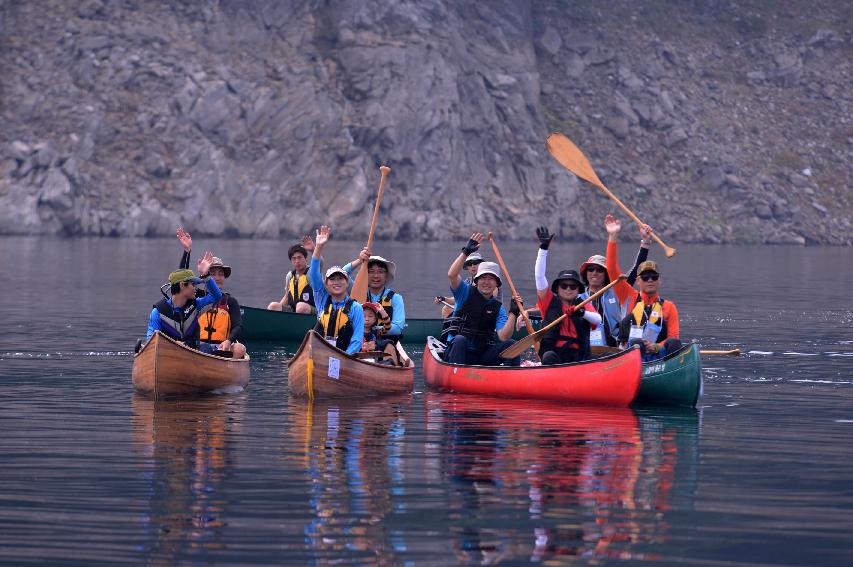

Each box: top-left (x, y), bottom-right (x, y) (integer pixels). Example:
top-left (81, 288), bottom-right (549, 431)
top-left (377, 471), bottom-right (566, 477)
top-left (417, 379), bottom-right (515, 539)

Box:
top-left (133, 331), bottom-right (249, 398)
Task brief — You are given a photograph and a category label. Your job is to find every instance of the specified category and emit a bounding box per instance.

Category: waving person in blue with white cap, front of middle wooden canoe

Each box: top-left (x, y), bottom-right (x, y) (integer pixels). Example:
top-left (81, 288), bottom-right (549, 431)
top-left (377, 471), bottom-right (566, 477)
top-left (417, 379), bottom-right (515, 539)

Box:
top-left (308, 225), bottom-right (364, 354)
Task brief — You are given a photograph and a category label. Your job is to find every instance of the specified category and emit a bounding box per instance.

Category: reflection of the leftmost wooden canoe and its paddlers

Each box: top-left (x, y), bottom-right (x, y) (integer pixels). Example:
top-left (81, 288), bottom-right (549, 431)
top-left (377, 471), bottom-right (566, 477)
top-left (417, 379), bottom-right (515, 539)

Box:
top-left (132, 394), bottom-right (246, 565)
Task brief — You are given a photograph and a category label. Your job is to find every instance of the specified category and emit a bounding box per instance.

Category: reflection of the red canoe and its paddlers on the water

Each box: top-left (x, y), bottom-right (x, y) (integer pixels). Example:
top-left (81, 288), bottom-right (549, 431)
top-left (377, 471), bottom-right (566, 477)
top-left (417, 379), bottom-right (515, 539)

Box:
top-left (426, 393), bottom-right (698, 563)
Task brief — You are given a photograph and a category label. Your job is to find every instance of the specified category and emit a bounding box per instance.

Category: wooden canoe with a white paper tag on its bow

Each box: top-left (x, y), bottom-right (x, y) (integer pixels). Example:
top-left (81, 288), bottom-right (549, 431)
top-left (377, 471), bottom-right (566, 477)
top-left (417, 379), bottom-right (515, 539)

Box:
top-left (287, 330), bottom-right (415, 398)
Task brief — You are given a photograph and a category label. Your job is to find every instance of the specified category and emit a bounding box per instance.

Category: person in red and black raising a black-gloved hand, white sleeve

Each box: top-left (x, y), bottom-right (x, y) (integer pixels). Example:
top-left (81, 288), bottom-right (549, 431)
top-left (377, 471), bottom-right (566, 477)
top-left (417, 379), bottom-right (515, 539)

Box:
top-left (534, 226), bottom-right (601, 365)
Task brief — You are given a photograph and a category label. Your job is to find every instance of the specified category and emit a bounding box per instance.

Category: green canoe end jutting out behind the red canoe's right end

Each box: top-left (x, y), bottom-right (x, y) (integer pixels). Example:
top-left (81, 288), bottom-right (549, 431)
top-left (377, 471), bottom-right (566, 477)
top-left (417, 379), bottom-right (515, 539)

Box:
top-left (634, 344), bottom-right (702, 408)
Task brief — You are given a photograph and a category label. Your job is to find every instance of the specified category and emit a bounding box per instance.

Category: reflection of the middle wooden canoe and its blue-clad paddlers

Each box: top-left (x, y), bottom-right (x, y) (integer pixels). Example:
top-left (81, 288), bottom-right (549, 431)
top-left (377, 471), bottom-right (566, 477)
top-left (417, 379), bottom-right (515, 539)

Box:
top-left (288, 394), bottom-right (412, 564)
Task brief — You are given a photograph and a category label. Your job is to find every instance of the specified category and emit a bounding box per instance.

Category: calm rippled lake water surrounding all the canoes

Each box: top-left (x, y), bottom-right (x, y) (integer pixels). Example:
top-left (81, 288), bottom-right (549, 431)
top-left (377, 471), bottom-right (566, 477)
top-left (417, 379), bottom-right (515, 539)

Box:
top-left (0, 238), bottom-right (853, 565)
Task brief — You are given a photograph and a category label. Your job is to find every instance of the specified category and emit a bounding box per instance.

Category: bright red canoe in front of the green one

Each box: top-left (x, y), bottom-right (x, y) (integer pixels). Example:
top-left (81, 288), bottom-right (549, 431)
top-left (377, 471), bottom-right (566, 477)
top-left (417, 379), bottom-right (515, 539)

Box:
top-left (424, 337), bottom-right (641, 406)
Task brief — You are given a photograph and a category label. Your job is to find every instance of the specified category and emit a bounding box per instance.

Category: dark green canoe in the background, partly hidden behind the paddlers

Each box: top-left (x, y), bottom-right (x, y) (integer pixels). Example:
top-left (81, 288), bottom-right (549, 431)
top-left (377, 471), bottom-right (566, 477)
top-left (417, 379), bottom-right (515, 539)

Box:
top-left (240, 307), bottom-right (541, 344)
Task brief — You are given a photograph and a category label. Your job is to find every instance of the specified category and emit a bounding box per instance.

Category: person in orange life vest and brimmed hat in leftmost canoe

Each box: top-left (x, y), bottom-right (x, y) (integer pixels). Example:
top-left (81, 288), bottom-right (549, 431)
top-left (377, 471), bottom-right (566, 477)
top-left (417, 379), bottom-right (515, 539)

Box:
top-left (177, 226), bottom-right (246, 358)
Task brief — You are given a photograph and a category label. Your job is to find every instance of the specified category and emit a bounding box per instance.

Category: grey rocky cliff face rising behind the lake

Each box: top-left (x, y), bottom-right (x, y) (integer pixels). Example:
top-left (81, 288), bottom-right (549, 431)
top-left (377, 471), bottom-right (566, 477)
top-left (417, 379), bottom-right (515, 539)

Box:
top-left (0, 0), bottom-right (853, 244)
